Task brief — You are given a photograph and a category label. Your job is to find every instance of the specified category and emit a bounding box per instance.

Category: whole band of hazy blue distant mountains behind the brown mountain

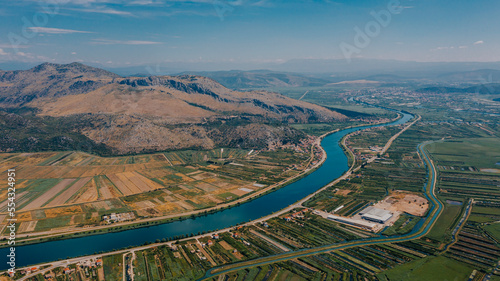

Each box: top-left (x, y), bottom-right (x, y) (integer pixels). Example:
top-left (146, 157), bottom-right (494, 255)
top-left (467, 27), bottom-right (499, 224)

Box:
top-left (0, 59), bottom-right (500, 89)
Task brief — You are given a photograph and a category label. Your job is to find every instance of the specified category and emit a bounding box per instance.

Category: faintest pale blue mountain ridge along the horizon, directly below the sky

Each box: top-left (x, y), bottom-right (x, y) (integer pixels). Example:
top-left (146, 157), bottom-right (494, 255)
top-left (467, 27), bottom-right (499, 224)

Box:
top-left (0, 58), bottom-right (500, 78)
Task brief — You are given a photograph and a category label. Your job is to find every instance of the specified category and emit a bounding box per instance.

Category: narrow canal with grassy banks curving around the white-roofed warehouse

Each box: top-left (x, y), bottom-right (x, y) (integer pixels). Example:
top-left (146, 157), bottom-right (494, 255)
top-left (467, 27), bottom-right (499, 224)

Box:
top-left (199, 139), bottom-right (443, 280)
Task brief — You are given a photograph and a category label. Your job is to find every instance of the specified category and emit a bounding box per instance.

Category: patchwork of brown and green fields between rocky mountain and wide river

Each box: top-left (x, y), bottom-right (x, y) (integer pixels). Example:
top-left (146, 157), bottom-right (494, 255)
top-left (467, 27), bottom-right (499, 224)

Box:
top-left (0, 147), bottom-right (310, 235)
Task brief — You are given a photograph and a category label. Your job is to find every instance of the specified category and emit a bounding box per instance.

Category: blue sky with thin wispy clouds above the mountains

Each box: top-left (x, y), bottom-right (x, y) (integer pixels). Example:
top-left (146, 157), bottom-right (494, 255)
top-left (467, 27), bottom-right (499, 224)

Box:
top-left (0, 0), bottom-right (500, 66)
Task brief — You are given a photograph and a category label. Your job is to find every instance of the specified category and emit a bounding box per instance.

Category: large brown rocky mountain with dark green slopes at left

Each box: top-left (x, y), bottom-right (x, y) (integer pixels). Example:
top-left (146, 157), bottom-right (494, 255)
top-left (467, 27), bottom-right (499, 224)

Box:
top-left (0, 63), bottom-right (346, 154)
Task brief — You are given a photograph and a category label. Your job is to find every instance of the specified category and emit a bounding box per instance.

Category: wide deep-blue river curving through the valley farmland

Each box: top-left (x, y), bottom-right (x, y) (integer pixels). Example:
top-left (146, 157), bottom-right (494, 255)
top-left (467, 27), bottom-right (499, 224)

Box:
top-left (0, 113), bottom-right (413, 270)
